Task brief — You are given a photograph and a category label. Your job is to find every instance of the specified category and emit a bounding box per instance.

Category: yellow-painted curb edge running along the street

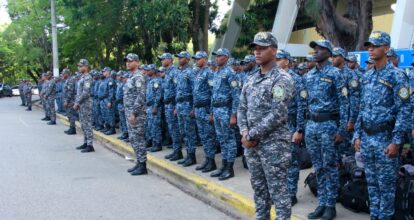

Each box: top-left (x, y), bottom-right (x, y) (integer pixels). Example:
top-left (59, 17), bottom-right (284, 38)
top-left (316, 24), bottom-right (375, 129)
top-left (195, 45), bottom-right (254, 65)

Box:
top-left (57, 111), bottom-right (300, 220)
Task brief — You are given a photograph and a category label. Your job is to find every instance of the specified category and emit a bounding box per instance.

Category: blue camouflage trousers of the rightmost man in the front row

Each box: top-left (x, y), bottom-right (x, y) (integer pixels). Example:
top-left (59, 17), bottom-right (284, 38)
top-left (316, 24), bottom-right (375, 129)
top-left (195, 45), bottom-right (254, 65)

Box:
top-left (361, 133), bottom-right (398, 219)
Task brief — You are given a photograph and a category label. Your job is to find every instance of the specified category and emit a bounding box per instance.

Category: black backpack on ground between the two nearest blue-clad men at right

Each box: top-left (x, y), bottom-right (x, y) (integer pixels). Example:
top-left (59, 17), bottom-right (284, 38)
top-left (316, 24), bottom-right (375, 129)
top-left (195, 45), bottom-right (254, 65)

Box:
top-left (339, 167), bottom-right (369, 213)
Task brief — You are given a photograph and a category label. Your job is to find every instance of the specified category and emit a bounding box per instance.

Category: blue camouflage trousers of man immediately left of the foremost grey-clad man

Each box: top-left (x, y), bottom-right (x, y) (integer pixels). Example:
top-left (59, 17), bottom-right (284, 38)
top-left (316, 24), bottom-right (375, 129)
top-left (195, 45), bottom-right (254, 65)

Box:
top-left (213, 107), bottom-right (237, 162)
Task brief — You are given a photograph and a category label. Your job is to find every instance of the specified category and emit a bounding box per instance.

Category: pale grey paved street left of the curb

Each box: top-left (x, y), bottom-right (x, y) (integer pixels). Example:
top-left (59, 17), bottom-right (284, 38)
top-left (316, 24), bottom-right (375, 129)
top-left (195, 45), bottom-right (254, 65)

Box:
top-left (0, 97), bottom-right (229, 220)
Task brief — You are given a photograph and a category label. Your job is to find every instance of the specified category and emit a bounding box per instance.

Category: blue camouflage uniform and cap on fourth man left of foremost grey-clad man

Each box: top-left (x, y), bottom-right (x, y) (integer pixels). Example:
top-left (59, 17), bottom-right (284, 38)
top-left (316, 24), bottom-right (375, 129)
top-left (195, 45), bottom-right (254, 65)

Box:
top-left (159, 53), bottom-right (181, 151)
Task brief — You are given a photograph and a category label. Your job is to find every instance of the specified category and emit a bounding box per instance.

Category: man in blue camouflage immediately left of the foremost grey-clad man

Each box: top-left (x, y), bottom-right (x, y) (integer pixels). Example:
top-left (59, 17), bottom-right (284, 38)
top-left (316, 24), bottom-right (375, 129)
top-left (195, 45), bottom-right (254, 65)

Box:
top-left (210, 48), bottom-right (240, 180)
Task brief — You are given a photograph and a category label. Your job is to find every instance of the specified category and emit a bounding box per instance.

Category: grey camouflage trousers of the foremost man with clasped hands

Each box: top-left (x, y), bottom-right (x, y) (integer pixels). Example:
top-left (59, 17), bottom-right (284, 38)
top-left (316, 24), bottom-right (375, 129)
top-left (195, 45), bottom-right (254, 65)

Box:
top-left (244, 140), bottom-right (291, 220)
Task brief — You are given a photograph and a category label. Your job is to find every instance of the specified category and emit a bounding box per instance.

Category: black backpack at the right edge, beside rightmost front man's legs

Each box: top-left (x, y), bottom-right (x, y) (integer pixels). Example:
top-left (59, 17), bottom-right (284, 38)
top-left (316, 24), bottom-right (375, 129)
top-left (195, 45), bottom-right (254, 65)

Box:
top-left (394, 165), bottom-right (414, 220)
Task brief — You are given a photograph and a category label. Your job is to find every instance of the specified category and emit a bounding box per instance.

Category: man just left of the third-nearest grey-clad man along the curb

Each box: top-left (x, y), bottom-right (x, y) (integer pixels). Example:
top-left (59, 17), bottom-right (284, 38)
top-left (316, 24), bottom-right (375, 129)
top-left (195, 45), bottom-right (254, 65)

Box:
top-left (62, 69), bottom-right (77, 135)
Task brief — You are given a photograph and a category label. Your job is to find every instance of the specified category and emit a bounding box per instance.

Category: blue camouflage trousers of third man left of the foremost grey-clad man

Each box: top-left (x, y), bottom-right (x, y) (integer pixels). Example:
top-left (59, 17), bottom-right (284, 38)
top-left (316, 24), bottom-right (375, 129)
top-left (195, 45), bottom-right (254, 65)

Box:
top-left (176, 102), bottom-right (197, 153)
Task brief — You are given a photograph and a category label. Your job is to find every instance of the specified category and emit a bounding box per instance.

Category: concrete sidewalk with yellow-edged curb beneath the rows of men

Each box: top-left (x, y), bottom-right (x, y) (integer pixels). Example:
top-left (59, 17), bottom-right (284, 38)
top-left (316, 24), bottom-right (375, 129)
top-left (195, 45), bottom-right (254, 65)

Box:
top-left (38, 102), bottom-right (370, 220)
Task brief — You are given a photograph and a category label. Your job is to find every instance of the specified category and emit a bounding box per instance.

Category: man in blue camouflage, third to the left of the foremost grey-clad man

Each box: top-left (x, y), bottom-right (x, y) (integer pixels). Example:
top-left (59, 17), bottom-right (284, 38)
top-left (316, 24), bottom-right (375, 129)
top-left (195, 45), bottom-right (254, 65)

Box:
top-left (175, 51), bottom-right (197, 167)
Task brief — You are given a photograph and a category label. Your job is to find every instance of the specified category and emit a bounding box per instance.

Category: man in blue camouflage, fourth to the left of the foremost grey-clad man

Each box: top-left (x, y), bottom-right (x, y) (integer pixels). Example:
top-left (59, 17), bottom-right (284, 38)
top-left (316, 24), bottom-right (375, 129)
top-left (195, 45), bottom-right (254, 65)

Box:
top-left (158, 53), bottom-right (183, 161)
